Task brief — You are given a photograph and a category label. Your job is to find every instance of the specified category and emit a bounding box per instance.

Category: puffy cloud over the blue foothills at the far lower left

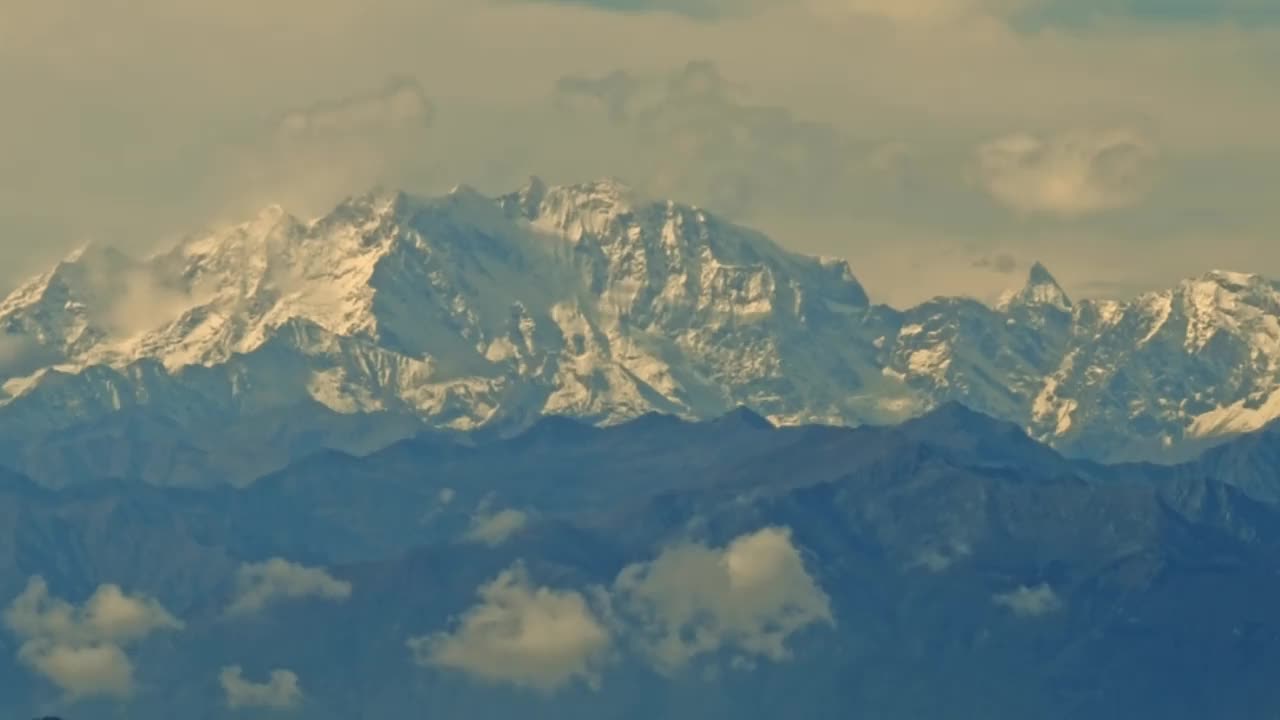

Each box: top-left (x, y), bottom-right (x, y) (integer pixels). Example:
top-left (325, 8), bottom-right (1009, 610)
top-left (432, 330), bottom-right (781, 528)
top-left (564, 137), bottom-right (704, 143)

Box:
top-left (4, 578), bottom-right (183, 697)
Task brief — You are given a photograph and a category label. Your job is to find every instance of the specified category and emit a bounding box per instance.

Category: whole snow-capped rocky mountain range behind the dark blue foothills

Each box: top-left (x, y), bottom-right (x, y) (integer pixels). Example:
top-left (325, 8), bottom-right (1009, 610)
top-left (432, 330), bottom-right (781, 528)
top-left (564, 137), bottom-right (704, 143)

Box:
top-left (0, 179), bottom-right (1280, 460)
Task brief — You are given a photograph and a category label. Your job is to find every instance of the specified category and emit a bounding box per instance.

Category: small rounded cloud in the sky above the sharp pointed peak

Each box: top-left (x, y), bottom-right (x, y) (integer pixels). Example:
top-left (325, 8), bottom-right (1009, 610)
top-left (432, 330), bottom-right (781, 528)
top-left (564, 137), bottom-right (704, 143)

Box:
top-left (978, 129), bottom-right (1156, 217)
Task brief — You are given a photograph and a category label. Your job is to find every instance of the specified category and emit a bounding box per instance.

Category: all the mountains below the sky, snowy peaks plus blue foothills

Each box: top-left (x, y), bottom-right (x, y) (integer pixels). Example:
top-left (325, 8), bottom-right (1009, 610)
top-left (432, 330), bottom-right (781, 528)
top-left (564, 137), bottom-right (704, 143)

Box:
top-left (0, 181), bottom-right (1280, 720)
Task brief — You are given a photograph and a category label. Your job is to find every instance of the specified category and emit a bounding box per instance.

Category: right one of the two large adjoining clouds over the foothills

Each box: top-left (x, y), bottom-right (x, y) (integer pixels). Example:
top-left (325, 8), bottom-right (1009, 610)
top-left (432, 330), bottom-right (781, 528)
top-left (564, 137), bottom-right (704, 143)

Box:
top-left (613, 528), bottom-right (835, 671)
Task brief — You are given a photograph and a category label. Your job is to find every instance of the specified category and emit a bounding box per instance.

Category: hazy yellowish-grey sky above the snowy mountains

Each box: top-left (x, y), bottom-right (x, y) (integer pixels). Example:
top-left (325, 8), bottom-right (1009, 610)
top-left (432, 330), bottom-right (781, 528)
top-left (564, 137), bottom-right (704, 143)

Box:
top-left (0, 0), bottom-right (1280, 305)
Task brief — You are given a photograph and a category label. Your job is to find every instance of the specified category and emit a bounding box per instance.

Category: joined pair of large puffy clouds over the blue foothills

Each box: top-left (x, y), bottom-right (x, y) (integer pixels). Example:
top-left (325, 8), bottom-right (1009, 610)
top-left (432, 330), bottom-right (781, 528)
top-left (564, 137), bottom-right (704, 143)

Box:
top-left (419, 528), bottom-right (835, 692)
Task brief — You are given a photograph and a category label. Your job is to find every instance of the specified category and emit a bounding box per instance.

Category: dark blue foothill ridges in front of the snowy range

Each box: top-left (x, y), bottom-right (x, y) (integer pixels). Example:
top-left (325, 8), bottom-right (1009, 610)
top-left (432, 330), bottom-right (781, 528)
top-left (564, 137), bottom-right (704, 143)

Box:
top-left (0, 404), bottom-right (1280, 720)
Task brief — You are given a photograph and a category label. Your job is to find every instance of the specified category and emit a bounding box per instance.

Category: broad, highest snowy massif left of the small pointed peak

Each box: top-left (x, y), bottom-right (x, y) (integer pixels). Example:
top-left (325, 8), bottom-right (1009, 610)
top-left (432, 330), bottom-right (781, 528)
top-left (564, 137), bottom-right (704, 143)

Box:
top-left (0, 178), bottom-right (867, 423)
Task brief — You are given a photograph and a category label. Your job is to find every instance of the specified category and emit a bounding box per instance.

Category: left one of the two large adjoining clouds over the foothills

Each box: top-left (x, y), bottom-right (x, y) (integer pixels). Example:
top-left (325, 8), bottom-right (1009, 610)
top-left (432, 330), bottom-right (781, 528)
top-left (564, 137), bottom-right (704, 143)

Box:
top-left (408, 565), bottom-right (612, 692)
